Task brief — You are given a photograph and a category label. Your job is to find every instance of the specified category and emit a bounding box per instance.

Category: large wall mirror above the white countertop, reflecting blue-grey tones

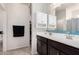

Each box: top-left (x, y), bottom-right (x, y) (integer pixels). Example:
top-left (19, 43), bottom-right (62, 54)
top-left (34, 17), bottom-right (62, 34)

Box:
top-left (48, 3), bottom-right (79, 35)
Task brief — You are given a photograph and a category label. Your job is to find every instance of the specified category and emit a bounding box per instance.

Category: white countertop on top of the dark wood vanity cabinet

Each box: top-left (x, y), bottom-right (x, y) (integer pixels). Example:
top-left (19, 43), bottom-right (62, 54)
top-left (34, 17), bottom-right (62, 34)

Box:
top-left (37, 32), bottom-right (79, 48)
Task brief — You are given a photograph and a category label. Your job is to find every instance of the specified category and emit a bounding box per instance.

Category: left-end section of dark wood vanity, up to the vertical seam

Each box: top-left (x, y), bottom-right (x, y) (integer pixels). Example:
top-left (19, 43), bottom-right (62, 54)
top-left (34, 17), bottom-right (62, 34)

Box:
top-left (37, 36), bottom-right (47, 55)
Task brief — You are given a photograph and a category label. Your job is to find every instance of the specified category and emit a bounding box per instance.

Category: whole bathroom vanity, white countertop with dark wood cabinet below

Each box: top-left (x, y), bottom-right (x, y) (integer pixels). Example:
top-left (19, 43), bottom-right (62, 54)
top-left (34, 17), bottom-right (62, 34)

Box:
top-left (37, 32), bottom-right (79, 55)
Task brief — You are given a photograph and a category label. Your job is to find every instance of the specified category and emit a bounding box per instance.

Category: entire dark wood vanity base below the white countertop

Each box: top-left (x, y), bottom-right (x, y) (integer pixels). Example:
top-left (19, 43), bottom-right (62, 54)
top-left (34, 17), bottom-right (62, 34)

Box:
top-left (37, 35), bottom-right (79, 55)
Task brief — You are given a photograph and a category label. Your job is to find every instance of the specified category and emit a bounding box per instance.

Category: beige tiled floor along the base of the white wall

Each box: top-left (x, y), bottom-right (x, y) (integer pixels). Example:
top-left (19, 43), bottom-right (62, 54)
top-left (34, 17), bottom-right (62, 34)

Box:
top-left (0, 48), bottom-right (31, 55)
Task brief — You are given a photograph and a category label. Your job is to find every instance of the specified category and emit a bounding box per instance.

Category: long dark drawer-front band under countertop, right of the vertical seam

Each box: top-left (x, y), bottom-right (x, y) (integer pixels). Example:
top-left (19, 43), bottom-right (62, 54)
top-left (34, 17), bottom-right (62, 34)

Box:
top-left (48, 39), bottom-right (79, 55)
